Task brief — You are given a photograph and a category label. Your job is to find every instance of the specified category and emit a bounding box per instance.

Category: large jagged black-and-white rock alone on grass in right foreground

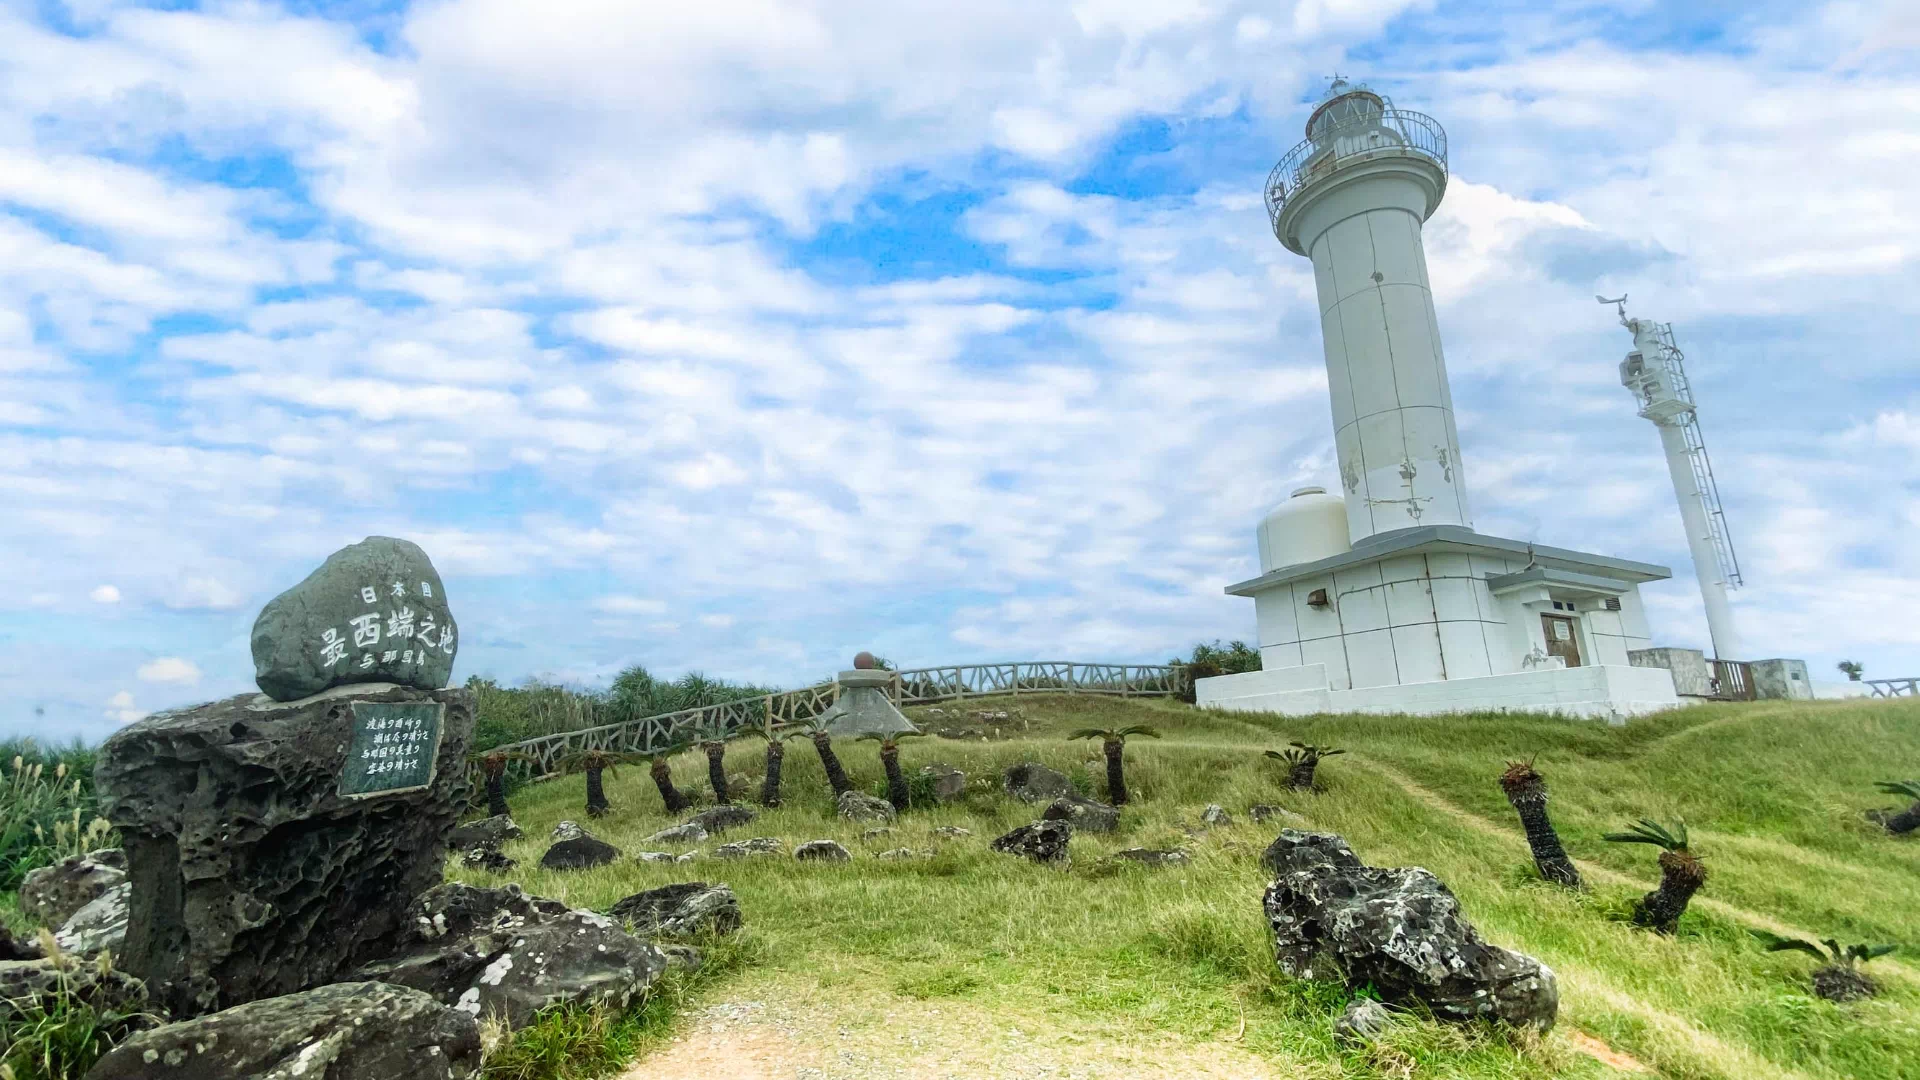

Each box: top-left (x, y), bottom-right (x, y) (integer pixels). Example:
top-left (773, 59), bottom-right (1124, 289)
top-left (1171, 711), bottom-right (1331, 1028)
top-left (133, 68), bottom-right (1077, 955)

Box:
top-left (1263, 830), bottom-right (1559, 1030)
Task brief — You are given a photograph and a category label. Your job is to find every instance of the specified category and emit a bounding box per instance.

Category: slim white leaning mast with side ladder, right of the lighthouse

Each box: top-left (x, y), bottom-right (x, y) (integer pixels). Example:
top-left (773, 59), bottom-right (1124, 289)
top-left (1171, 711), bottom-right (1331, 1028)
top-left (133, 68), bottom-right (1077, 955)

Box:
top-left (1594, 296), bottom-right (1743, 659)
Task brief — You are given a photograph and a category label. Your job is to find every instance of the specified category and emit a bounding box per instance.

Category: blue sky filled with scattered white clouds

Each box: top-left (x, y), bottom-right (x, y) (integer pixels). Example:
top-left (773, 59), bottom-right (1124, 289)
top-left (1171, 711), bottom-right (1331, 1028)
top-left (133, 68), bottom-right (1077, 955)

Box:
top-left (0, 0), bottom-right (1920, 738)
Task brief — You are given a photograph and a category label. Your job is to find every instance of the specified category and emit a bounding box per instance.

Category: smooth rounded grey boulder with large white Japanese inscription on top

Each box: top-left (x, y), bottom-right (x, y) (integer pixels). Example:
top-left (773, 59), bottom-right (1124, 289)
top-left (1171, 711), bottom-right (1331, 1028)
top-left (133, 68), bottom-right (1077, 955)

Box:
top-left (253, 536), bottom-right (457, 701)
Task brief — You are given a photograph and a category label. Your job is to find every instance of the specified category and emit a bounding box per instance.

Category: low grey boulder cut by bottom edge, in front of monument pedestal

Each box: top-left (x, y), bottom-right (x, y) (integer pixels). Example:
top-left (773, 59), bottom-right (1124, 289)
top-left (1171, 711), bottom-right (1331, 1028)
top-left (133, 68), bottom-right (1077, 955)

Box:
top-left (86, 982), bottom-right (480, 1080)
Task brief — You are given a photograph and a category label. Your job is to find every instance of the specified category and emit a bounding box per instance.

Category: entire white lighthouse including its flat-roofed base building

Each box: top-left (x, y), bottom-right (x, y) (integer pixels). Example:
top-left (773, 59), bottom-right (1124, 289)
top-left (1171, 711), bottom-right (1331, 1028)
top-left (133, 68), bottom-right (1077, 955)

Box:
top-left (1194, 79), bottom-right (1678, 721)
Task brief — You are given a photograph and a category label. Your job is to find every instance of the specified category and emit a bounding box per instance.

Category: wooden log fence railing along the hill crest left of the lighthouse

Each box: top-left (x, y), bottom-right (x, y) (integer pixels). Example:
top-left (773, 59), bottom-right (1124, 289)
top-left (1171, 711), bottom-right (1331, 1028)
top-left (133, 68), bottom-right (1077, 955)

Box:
top-left (472, 661), bottom-right (1187, 790)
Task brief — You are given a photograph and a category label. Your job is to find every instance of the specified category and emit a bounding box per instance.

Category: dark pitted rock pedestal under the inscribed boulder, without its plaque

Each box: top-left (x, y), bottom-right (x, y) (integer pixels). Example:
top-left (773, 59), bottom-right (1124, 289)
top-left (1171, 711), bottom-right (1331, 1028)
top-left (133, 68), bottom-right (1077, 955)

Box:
top-left (94, 686), bottom-right (474, 1019)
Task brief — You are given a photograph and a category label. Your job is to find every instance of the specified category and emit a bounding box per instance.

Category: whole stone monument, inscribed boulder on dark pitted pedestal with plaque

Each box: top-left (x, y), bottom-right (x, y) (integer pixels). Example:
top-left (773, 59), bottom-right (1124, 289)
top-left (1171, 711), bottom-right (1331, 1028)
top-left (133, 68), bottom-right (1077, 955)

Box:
top-left (96, 536), bottom-right (474, 1017)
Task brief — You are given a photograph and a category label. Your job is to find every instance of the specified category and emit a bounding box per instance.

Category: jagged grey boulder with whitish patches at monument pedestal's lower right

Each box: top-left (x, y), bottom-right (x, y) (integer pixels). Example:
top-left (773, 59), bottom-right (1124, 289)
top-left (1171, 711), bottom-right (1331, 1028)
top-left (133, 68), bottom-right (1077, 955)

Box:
top-left (355, 882), bottom-right (666, 1028)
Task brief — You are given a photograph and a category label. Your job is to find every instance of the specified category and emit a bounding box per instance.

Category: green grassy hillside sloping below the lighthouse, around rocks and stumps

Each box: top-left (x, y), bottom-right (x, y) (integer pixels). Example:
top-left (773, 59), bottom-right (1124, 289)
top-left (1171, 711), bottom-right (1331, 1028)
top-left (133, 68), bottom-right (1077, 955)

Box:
top-left (453, 696), bottom-right (1920, 1080)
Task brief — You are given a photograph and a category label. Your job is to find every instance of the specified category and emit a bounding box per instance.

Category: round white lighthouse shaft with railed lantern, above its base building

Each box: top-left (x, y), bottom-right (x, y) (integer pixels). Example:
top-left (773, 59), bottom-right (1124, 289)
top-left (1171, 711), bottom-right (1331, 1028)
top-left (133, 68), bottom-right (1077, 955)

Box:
top-left (1269, 83), bottom-right (1473, 544)
